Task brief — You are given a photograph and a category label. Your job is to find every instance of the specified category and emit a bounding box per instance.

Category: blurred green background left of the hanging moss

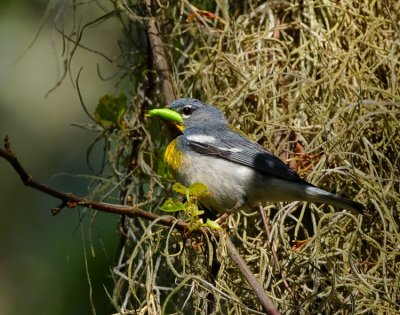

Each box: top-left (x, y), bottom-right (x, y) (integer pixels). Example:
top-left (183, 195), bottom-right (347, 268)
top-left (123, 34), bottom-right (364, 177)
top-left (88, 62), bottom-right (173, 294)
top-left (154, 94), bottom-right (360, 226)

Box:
top-left (0, 0), bottom-right (119, 315)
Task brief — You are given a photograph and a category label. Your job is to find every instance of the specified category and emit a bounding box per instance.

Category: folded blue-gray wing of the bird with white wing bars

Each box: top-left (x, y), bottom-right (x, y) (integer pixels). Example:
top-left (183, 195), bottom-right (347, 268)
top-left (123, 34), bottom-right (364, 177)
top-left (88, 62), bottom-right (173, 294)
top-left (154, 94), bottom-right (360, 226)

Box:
top-left (185, 128), bottom-right (311, 185)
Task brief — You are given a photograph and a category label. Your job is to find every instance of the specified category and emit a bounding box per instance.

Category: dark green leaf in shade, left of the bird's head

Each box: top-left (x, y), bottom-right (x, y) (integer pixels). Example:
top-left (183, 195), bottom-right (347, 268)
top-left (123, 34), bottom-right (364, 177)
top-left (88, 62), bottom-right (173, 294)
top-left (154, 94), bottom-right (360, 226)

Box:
top-left (94, 93), bottom-right (127, 129)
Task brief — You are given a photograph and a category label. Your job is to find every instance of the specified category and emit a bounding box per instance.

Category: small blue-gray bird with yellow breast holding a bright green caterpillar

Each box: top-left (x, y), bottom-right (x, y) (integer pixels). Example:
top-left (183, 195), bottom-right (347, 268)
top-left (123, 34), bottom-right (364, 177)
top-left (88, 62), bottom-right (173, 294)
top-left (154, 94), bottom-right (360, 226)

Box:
top-left (149, 98), bottom-right (364, 212)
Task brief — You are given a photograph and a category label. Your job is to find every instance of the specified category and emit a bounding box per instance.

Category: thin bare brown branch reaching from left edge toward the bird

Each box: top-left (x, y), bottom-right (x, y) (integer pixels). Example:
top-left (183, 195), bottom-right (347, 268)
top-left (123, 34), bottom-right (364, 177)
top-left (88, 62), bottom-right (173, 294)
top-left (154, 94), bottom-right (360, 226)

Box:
top-left (0, 136), bottom-right (188, 231)
